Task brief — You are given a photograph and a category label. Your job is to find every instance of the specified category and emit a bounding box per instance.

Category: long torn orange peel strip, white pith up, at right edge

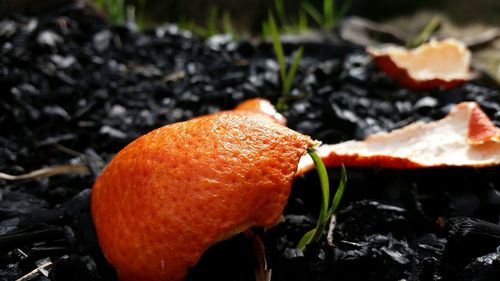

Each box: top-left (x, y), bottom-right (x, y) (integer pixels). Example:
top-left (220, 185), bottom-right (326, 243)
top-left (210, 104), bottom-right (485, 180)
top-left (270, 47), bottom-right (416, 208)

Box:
top-left (297, 102), bottom-right (500, 175)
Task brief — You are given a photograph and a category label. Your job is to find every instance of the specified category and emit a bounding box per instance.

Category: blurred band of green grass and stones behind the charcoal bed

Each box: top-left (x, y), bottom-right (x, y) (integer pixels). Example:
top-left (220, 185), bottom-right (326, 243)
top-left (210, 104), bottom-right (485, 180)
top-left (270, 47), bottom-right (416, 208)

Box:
top-left (0, 0), bottom-right (500, 79)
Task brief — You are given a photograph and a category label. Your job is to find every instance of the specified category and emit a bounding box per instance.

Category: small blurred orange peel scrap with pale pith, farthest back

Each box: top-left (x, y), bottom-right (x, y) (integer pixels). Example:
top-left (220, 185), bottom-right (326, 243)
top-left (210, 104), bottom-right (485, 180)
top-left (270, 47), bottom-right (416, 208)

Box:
top-left (367, 39), bottom-right (471, 90)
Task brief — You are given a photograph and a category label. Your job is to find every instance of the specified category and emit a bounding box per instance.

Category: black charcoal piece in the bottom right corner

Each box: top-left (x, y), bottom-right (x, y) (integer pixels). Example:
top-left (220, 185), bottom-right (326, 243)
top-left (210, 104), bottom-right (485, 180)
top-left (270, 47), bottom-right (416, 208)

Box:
top-left (458, 252), bottom-right (500, 281)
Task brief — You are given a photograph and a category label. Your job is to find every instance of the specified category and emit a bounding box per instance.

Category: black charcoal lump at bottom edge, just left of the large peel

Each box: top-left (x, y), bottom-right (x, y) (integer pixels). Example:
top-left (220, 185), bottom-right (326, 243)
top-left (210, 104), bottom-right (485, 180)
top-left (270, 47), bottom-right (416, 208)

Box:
top-left (49, 255), bottom-right (103, 281)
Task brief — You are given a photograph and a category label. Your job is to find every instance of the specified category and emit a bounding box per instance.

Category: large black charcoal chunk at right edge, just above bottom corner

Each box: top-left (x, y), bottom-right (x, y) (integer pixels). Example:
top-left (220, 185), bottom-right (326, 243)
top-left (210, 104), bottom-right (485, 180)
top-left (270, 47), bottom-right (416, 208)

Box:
top-left (444, 217), bottom-right (500, 269)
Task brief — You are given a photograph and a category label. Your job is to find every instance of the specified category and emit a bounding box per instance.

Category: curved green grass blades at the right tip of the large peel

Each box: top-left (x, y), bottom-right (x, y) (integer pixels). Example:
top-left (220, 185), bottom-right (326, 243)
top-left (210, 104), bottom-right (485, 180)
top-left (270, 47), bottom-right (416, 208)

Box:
top-left (297, 149), bottom-right (347, 250)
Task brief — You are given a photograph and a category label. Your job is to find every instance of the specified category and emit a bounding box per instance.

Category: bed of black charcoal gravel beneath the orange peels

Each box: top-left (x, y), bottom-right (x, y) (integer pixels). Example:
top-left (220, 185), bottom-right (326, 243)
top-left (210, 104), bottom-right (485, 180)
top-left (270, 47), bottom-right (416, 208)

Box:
top-left (0, 6), bottom-right (500, 281)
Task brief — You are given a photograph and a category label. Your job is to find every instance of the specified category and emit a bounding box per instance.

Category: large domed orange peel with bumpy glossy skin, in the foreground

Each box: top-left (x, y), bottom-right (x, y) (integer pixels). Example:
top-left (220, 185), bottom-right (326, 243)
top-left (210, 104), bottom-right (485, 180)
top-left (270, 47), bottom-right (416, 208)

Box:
top-left (92, 111), bottom-right (311, 281)
